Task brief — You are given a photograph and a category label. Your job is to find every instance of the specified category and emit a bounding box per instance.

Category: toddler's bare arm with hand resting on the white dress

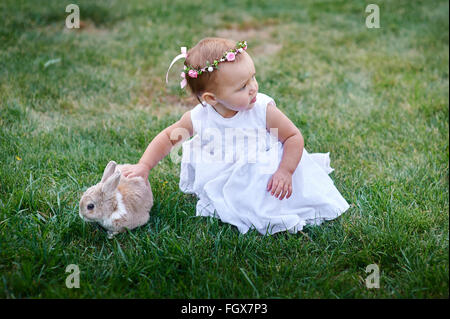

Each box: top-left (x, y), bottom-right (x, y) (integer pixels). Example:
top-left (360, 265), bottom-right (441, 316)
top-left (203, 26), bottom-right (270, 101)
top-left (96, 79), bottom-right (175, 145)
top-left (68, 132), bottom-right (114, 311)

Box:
top-left (266, 102), bottom-right (304, 200)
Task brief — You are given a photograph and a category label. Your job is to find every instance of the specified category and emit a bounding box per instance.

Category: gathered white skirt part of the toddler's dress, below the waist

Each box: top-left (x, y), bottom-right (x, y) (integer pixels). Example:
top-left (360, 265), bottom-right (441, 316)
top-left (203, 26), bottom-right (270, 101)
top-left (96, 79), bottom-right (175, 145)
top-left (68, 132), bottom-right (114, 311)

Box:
top-left (179, 139), bottom-right (349, 235)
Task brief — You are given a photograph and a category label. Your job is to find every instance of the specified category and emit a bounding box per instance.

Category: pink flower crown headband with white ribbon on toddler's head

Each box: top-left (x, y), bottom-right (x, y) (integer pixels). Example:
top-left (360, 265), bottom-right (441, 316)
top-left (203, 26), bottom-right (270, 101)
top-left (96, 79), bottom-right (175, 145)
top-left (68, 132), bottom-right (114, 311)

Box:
top-left (166, 41), bottom-right (247, 89)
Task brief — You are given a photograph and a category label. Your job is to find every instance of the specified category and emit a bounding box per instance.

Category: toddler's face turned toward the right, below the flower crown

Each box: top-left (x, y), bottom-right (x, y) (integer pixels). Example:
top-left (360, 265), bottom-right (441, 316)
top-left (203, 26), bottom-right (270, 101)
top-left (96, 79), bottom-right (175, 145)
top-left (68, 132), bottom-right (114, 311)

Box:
top-left (210, 51), bottom-right (258, 111)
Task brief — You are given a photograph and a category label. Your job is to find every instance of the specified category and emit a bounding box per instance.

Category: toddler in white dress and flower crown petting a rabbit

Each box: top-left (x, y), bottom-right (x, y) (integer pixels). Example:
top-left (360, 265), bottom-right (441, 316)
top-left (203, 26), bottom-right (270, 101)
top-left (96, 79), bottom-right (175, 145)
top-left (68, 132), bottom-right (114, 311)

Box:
top-left (123, 38), bottom-right (349, 234)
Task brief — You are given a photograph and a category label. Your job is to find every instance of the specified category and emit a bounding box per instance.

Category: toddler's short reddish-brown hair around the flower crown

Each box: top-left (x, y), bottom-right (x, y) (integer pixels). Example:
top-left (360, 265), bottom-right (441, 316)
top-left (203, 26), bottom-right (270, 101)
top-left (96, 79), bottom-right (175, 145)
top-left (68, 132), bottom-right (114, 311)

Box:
top-left (184, 37), bottom-right (242, 103)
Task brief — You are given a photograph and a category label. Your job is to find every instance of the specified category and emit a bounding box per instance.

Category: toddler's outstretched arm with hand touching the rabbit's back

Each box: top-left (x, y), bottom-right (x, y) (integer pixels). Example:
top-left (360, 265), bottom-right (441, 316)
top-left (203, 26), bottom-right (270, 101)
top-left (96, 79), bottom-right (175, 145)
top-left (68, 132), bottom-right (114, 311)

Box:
top-left (122, 111), bottom-right (193, 179)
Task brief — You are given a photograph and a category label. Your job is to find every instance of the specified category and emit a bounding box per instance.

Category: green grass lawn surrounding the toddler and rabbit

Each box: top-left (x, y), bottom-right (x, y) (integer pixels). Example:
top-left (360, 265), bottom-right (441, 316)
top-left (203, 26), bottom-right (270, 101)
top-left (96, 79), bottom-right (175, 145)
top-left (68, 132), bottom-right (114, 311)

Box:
top-left (0, 0), bottom-right (449, 298)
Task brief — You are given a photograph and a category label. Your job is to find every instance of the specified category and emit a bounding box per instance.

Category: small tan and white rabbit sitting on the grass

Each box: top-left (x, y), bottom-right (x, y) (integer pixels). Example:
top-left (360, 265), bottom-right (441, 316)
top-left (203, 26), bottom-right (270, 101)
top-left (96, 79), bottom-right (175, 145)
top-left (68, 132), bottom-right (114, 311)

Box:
top-left (79, 161), bottom-right (153, 239)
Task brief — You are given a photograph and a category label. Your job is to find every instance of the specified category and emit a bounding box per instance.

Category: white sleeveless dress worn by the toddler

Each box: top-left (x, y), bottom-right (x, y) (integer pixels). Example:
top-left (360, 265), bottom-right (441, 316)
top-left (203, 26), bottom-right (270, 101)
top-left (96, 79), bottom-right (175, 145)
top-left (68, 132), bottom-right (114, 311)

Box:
top-left (179, 93), bottom-right (349, 234)
